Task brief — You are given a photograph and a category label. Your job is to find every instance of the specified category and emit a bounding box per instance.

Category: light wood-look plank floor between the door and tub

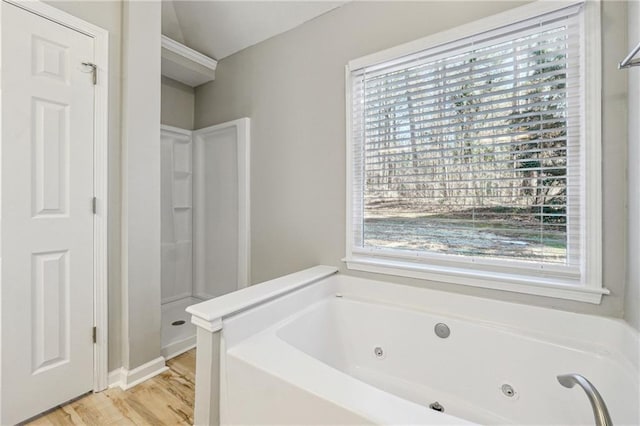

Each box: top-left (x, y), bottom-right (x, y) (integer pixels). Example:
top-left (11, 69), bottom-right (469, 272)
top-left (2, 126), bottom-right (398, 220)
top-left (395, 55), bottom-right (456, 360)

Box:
top-left (27, 349), bottom-right (196, 426)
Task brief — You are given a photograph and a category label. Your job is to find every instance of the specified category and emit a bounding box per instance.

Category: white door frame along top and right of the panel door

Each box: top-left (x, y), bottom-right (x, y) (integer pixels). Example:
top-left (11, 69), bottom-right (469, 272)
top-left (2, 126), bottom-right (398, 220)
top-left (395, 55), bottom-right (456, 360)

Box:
top-left (0, 0), bottom-right (109, 392)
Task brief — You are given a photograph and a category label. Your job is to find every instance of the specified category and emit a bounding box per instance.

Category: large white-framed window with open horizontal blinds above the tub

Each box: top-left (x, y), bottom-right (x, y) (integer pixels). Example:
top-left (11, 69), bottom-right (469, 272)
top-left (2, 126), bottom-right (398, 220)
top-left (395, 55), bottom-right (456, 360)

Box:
top-left (346, 3), bottom-right (606, 303)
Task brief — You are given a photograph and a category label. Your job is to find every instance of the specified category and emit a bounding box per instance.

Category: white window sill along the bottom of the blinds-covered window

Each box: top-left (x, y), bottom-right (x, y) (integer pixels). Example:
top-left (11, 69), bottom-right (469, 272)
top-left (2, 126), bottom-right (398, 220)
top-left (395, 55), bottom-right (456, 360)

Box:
top-left (343, 256), bottom-right (609, 304)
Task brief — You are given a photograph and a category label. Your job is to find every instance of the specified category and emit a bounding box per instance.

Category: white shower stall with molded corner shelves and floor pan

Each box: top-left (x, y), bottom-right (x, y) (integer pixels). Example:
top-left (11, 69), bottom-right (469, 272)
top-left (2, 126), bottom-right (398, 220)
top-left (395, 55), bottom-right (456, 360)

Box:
top-left (160, 118), bottom-right (250, 359)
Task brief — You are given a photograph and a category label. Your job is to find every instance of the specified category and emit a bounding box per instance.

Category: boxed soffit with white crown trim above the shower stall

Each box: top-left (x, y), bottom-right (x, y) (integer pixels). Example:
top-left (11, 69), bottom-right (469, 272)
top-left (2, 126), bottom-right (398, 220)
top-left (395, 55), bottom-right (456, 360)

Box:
top-left (162, 35), bottom-right (218, 87)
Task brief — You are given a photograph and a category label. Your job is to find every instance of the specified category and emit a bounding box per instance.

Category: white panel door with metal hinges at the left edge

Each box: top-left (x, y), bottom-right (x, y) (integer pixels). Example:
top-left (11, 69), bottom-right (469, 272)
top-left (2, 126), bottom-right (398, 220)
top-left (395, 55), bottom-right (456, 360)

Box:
top-left (0, 2), bottom-right (94, 424)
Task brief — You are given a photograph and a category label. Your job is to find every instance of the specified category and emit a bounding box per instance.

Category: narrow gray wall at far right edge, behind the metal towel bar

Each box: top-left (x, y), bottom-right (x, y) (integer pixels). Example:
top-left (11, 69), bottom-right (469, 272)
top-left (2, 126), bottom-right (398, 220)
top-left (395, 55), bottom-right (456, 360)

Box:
top-left (624, 1), bottom-right (640, 330)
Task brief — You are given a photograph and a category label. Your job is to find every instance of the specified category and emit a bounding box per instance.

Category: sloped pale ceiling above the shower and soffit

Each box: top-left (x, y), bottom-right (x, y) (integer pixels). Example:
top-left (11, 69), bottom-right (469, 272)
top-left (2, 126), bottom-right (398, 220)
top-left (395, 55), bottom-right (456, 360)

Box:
top-left (162, 0), bottom-right (346, 60)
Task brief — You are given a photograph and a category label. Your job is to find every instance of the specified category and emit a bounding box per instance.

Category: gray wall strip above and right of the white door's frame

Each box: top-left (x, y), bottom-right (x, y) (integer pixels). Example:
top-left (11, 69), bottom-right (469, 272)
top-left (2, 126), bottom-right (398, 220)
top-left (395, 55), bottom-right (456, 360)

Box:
top-left (47, 0), bottom-right (122, 371)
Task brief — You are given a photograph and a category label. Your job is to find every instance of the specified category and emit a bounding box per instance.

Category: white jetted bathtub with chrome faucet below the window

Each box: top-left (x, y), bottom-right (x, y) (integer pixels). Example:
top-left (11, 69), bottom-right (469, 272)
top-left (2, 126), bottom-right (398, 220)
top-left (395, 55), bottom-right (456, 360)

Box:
top-left (192, 268), bottom-right (640, 425)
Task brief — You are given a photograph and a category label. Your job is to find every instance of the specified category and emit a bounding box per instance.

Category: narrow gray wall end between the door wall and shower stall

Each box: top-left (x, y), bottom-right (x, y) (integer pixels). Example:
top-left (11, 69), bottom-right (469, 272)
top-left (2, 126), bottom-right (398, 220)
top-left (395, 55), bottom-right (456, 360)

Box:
top-left (121, 1), bottom-right (161, 369)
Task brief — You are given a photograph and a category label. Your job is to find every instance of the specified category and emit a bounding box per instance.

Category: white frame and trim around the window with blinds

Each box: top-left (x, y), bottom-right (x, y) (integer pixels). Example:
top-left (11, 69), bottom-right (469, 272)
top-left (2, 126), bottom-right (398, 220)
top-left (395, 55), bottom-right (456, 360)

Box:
top-left (343, 0), bottom-right (609, 304)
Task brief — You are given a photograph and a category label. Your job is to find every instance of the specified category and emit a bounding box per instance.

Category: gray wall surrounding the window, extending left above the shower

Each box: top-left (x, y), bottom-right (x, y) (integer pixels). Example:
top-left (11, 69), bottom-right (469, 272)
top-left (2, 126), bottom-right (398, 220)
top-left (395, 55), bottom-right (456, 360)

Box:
top-left (194, 1), bottom-right (627, 317)
